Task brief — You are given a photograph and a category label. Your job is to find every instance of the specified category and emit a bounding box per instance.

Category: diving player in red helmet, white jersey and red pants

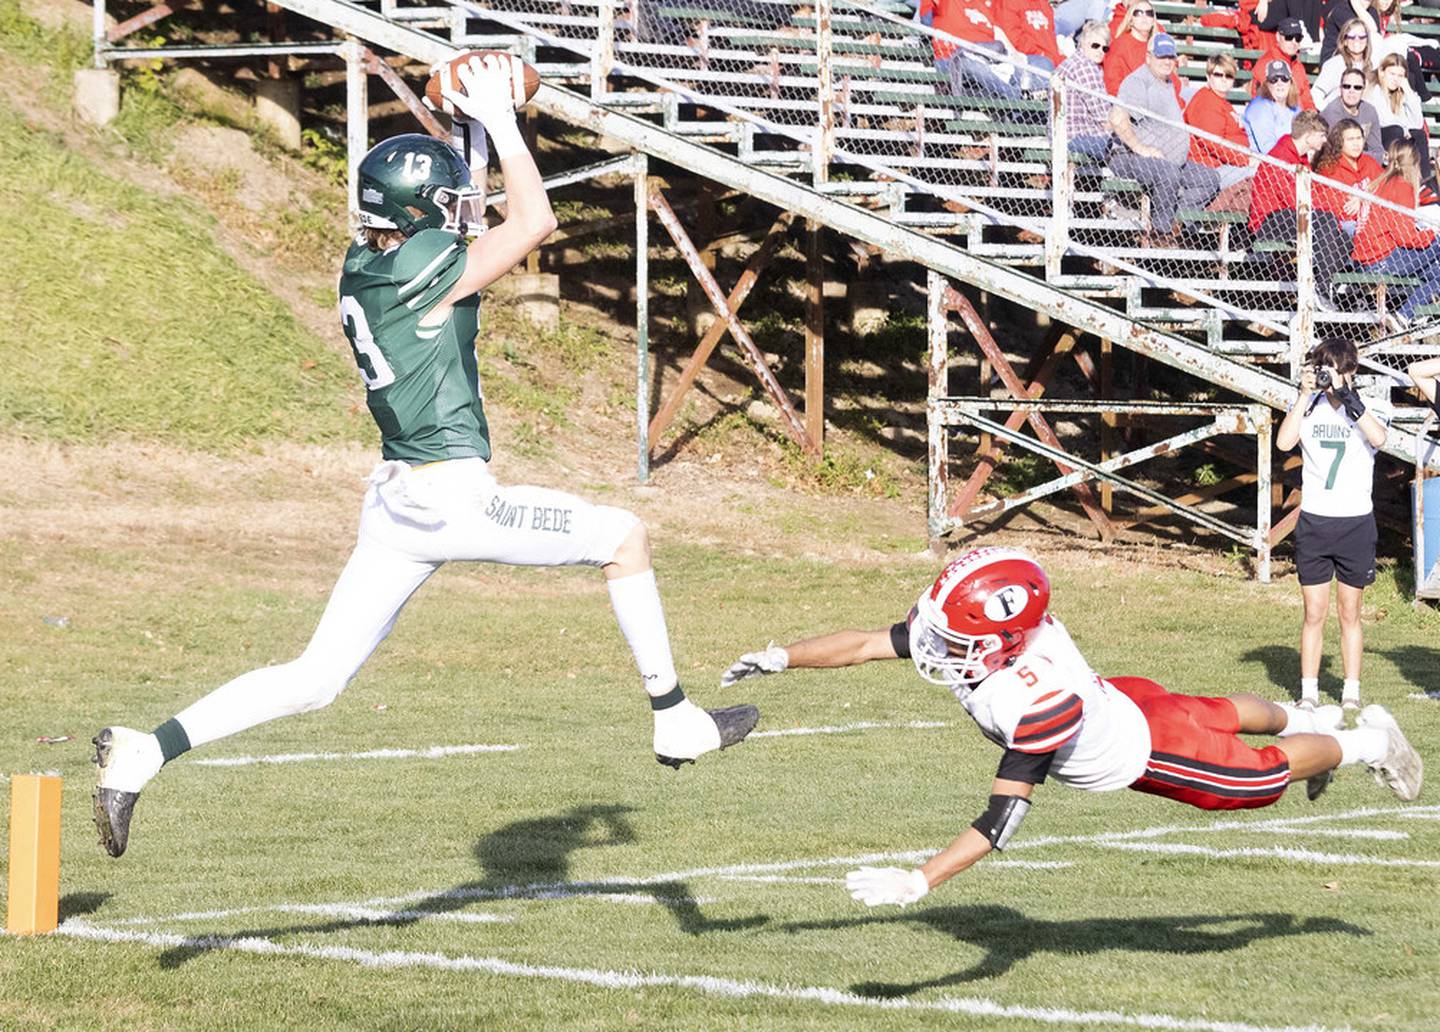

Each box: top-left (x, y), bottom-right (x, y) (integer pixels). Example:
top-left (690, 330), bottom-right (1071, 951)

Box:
top-left (721, 547), bottom-right (1423, 907)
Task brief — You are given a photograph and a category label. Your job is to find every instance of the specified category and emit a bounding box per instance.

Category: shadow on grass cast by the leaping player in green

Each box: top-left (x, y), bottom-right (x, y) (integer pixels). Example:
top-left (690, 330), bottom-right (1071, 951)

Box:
top-left (160, 805), bottom-right (769, 967)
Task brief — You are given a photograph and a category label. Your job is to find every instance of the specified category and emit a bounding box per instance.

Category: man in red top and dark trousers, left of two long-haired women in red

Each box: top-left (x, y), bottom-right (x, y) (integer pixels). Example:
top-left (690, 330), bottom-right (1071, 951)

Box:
top-left (1250, 111), bottom-right (1351, 302)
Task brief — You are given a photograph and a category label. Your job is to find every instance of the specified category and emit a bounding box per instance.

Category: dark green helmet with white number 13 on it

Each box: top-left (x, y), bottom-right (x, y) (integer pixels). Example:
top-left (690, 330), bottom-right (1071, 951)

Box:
top-left (356, 132), bottom-right (485, 236)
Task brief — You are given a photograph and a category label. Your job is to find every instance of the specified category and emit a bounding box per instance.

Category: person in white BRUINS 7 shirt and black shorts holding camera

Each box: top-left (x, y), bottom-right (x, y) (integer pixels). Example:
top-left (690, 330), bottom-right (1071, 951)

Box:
top-left (1276, 337), bottom-right (1388, 710)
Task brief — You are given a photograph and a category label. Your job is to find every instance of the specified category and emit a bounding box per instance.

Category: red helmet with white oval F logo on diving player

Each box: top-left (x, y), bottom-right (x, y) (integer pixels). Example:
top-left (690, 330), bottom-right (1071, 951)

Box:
top-left (910, 547), bottom-right (1050, 688)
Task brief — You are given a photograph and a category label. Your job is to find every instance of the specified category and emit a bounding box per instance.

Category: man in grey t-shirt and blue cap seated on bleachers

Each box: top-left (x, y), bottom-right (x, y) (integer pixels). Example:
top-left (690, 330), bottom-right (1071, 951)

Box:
top-left (1109, 33), bottom-right (1220, 243)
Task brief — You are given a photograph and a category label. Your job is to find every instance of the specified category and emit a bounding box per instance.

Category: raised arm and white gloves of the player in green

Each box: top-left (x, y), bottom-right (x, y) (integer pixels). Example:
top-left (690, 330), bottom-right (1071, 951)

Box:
top-left (423, 55), bottom-right (556, 309)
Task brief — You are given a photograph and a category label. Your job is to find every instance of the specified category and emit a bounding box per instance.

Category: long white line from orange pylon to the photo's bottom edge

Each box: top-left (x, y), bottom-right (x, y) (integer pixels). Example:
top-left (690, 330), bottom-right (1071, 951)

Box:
top-left (58, 920), bottom-right (1339, 1032)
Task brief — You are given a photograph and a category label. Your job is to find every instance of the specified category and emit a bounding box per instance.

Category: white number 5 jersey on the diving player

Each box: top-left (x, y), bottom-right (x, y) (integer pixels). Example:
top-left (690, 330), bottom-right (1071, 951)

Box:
top-left (958, 616), bottom-right (1151, 792)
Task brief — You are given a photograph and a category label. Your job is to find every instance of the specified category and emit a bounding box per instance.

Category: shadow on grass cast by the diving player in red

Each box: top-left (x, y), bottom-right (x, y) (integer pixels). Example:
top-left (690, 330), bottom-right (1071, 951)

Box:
top-left (782, 905), bottom-right (1372, 997)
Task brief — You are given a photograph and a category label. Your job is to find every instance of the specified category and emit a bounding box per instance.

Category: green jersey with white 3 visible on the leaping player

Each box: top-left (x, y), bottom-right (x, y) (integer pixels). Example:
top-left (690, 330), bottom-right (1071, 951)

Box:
top-left (340, 229), bottom-right (490, 465)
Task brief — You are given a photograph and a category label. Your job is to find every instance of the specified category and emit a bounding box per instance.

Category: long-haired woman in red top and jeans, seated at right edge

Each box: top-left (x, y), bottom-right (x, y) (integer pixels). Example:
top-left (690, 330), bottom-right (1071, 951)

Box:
top-left (1354, 140), bottom-right (1440, 328)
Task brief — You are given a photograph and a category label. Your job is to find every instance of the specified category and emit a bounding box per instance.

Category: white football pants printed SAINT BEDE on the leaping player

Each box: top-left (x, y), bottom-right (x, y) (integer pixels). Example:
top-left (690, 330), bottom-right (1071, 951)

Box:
top-left (176, 459), bottom-right (639, 746)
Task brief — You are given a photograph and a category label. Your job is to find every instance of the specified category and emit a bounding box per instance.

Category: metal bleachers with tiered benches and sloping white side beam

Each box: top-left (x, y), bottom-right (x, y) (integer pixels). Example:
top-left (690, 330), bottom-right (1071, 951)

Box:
top-left (216, 0), bottom-right (1440, 489)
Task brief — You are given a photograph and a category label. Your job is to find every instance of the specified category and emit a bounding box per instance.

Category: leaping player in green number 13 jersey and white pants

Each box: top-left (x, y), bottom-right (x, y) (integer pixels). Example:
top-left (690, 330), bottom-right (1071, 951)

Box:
top-left (94, 55), bottom-right (759, 856)
